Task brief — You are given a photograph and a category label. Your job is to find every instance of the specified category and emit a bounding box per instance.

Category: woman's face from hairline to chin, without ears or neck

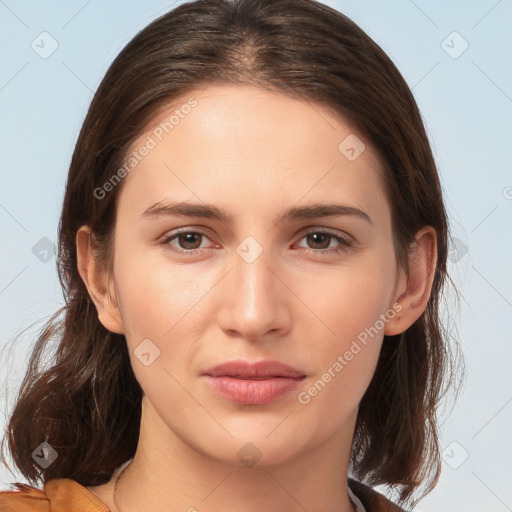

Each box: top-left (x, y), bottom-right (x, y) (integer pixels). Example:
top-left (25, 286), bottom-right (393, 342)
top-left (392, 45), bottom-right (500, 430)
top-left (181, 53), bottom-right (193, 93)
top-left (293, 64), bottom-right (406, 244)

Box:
top-left (101, 85), bottom-right (401, 464)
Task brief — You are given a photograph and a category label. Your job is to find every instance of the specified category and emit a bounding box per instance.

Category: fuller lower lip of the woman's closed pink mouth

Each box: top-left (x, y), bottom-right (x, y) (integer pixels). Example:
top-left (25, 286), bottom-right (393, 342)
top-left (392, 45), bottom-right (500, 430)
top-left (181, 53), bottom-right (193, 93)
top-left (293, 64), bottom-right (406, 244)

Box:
top-left (202, 375), bottom-right (305, 405)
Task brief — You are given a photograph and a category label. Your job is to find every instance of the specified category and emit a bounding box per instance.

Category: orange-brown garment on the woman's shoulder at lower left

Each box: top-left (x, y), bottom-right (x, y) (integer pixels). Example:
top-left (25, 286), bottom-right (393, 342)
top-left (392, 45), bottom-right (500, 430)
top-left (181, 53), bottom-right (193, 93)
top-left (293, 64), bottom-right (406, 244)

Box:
top-left (0, 478), bottom-right (110, 512)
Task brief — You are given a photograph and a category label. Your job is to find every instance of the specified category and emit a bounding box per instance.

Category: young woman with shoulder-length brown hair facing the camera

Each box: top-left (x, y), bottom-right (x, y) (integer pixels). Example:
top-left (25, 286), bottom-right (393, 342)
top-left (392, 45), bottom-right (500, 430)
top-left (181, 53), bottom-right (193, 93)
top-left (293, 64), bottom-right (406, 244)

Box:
top-left (0, 0), bottom-right (456, 512)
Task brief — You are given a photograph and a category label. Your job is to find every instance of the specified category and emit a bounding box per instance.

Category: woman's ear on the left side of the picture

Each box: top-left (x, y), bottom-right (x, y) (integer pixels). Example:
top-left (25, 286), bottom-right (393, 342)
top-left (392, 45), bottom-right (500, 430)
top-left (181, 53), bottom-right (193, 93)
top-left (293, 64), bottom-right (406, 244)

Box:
top-left (76, 226), bottom-right (124, 334)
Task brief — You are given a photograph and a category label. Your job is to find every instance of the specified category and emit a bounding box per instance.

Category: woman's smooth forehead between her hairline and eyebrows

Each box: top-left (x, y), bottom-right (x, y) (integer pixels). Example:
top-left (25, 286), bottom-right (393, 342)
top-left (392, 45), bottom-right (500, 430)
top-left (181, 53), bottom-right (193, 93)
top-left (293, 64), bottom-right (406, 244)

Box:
top-left (115, 84), bottom-right (385, 222)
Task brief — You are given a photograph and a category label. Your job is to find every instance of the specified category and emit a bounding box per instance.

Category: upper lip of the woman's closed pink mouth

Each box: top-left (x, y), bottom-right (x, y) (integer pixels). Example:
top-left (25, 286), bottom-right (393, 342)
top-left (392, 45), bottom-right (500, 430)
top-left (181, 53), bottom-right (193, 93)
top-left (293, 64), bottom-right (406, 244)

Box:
top-left (204, 360), bottom-right (305, 379)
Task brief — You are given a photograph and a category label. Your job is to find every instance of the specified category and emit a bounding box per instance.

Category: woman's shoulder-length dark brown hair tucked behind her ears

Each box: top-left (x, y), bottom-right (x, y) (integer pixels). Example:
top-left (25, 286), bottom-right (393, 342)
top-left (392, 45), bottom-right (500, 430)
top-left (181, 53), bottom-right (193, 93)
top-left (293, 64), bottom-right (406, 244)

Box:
top-left (2, 0), bottom-right (460, 503)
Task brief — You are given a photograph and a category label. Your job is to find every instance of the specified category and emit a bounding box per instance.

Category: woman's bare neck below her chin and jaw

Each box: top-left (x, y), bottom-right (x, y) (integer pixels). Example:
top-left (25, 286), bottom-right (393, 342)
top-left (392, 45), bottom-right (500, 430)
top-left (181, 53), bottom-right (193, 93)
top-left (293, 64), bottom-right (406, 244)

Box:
top-left (115, 397), bottom-right (356, 512)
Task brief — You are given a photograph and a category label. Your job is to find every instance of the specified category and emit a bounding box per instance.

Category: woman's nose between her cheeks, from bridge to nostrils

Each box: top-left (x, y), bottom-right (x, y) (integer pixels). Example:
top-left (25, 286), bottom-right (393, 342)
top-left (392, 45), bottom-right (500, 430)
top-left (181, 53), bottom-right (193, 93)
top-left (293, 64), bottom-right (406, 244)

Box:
top-left (218, 241), bottom-right (292, 341)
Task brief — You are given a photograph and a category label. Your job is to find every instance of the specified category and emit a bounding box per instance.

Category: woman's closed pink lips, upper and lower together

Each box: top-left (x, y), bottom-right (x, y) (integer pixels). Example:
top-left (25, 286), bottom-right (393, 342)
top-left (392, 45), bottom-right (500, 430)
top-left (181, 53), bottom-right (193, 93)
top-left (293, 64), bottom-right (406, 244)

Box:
top-left (203, 361), bottom-right (306, 405)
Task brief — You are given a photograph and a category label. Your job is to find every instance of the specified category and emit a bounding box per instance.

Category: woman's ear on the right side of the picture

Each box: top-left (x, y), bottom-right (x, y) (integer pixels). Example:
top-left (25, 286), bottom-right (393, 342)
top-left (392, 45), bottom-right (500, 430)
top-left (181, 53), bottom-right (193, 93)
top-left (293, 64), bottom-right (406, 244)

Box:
top-left (384, 226), bottom-right (437, 336)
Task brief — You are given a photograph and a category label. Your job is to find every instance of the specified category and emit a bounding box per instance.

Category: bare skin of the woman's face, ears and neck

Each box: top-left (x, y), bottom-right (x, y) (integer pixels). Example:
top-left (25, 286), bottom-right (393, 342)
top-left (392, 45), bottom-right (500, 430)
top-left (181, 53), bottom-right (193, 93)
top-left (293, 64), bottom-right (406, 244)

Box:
top-left (77, 84), bottom-right (436, 512)
